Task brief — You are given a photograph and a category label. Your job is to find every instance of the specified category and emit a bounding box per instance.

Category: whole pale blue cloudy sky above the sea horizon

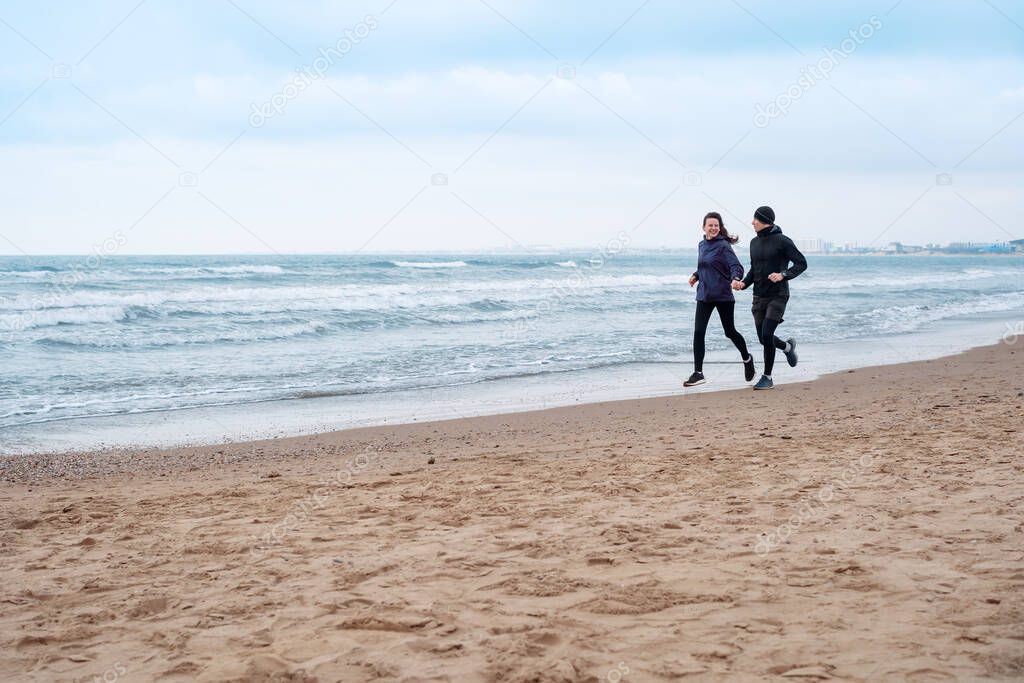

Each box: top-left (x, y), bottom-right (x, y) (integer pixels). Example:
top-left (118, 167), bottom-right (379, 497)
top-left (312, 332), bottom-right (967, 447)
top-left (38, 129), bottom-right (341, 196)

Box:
top-left (0, 0), bottom-right (1024, 255)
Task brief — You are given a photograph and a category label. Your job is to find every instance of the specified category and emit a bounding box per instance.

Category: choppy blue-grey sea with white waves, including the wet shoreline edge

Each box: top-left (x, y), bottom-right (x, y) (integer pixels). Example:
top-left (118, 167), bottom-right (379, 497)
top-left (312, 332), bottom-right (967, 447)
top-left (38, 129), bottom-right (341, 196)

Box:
top-left (0, 250), bottom-right (1024, 455)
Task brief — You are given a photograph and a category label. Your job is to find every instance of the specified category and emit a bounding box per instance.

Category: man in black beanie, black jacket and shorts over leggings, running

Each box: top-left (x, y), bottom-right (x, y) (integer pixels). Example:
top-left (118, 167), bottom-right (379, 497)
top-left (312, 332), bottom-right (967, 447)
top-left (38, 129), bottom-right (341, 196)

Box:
top-left (732, 206), bottom-right (807, 389)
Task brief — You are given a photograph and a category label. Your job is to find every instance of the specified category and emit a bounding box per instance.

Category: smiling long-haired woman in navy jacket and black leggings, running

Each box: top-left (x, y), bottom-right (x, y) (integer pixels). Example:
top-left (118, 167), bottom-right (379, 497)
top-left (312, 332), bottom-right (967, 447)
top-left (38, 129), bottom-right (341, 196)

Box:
top-left (683, 211), bottom-right (756, 387)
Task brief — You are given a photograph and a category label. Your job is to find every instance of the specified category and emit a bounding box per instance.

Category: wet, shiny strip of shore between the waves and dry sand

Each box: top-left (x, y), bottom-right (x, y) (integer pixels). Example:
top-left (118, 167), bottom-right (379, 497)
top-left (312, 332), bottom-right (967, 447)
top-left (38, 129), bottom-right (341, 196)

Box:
top-left (6, 311), bottom-right (1010, 459)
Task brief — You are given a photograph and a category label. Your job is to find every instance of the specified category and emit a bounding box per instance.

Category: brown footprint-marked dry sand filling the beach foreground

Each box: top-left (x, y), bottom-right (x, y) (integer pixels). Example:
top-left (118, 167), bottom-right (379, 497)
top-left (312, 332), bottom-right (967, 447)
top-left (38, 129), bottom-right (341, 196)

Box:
top-left (0, 344), bottom-right (1024, 683)
